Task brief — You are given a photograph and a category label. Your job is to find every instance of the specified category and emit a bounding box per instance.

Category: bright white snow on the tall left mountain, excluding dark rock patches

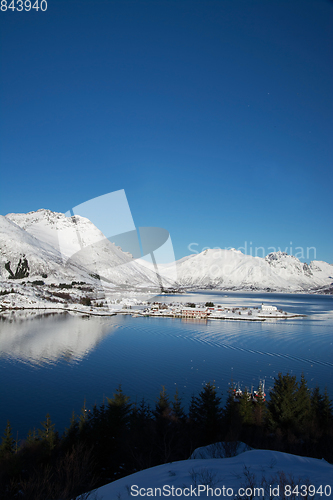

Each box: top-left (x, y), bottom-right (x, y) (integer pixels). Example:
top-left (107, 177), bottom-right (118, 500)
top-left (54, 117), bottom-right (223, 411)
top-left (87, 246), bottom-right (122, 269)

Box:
top-left (0, 209), bottom-right (171, 287)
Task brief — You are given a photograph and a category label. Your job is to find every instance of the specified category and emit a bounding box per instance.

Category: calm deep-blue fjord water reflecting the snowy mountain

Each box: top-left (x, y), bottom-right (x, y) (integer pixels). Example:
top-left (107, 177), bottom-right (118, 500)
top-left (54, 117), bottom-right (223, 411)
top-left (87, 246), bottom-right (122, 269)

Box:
top-left (0, 292), bottom-right (333, 439)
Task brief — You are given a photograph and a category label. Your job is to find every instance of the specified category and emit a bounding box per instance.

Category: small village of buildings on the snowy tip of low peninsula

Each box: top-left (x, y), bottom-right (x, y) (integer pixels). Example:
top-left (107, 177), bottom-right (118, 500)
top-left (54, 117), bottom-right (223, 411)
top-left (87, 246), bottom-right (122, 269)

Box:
top-left (133, 302), bottom-right (303, 321)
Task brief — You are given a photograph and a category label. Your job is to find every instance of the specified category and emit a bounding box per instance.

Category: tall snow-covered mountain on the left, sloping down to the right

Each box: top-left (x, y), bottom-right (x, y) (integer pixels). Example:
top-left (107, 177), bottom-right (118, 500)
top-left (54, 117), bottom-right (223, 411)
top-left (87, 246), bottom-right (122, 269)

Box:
top-left (0, 209), bottom-right (169, 287)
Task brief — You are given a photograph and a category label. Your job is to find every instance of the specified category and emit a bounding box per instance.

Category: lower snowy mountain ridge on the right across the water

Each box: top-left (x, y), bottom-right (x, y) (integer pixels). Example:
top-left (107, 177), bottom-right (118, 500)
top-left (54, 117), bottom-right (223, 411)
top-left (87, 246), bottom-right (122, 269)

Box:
top-left (164, 249), bottom-right (333, 292)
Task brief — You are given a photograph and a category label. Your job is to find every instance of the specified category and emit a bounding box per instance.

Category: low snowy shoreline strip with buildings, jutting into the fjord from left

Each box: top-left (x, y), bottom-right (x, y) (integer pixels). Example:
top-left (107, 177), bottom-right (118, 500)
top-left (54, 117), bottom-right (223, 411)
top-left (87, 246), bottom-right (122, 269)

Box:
top-left (0, 283), bottom-right (305, 321)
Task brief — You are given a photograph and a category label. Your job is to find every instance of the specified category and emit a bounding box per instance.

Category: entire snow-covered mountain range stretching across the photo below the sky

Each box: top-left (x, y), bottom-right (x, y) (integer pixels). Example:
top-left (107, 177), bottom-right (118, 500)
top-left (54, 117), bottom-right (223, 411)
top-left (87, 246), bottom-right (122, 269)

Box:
top-left (0, 209), bottom-right (333, 293)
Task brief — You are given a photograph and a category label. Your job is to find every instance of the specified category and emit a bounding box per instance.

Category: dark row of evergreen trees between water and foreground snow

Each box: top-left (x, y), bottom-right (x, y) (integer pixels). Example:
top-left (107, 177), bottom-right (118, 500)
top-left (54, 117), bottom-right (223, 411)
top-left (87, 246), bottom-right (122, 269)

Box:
top-left (0, 374), bottom-right (333, 500)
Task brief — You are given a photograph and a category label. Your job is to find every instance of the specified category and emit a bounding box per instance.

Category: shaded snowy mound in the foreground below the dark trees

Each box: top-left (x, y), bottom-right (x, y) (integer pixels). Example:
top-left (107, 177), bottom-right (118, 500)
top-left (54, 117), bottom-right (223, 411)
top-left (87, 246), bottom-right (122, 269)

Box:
top-left (89, 444), bottom-right (333, 500)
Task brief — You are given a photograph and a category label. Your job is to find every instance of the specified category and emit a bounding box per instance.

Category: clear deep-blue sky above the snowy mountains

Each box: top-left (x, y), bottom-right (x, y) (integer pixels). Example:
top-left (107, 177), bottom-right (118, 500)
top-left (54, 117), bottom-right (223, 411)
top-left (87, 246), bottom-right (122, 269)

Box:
top-left (0, 0), bottom-right (333, 263)
